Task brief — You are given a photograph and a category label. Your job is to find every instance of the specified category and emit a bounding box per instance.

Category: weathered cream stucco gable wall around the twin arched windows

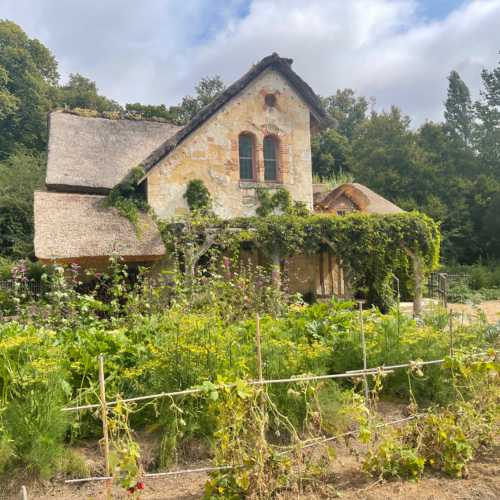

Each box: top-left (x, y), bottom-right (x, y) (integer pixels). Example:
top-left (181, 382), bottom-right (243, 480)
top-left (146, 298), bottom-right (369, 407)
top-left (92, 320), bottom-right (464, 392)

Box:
top-left (148, 70), bottom-right (312, 218)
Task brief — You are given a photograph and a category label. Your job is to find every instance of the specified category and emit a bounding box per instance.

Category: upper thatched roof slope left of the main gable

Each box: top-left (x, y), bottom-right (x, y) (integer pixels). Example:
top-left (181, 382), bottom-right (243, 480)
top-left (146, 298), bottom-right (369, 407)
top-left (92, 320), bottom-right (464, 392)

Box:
top-left (46, 111), bottom-right (180, 194)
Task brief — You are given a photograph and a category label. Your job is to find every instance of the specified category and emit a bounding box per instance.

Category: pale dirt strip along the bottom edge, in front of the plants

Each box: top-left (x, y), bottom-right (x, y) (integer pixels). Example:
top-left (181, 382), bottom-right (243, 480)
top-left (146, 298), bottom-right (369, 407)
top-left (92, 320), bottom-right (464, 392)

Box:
top-left (6, 446), bottom-right (500, 500)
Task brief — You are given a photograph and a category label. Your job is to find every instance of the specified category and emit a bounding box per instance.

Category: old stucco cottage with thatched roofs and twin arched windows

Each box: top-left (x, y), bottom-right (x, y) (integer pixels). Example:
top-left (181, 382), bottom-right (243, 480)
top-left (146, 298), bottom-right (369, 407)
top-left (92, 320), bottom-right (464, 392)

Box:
top-left (34, 54), bottom-right (399, 295)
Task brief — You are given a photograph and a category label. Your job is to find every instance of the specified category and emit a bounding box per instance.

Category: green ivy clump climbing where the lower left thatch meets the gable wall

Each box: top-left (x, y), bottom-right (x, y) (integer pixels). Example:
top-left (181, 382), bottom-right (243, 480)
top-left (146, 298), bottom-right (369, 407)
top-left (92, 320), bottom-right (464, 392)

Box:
top-left (105, 167), bottom-right (148, 231)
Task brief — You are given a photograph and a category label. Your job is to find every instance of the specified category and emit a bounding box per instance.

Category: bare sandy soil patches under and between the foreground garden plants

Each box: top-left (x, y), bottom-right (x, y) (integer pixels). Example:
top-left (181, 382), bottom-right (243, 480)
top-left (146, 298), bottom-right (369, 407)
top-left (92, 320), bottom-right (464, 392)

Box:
top-left (4, 401), bottom-right (500, 500)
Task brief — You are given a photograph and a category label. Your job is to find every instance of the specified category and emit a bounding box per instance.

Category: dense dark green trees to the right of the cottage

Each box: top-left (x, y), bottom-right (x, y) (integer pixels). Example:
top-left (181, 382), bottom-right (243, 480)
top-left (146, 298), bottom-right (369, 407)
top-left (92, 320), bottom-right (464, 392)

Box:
top-left (313, 65), bottom-right (500, 263)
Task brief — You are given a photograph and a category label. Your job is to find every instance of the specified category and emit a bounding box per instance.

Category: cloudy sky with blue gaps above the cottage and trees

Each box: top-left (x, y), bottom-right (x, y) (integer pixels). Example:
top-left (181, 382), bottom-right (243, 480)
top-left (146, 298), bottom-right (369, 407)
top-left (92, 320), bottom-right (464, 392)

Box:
top-left (0, 0), bottom-right (500, 124)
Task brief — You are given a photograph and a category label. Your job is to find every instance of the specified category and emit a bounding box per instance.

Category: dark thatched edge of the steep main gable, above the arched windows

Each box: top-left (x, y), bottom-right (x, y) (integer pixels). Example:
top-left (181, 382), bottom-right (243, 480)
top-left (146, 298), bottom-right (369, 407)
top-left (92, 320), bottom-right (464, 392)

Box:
top-left (142, 53), bottom-right (335, 177)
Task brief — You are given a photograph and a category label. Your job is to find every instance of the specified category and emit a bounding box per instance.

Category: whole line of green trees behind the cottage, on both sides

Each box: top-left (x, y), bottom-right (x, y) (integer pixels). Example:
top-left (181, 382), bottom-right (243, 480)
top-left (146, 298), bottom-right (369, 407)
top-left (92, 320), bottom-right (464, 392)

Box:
top-left (0, 21), bottom-right (500, 262)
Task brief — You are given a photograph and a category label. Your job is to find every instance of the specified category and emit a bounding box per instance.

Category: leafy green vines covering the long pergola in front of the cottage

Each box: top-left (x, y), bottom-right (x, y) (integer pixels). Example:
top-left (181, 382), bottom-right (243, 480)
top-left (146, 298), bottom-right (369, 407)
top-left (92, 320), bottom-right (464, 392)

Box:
top-left (162, 212), bottom-right (440, 307)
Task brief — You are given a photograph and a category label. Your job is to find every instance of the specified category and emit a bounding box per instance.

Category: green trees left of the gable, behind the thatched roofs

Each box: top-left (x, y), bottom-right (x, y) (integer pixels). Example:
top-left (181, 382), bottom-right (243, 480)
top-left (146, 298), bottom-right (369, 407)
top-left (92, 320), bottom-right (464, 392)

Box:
top-left (0, 20), bottom-right (224, 259)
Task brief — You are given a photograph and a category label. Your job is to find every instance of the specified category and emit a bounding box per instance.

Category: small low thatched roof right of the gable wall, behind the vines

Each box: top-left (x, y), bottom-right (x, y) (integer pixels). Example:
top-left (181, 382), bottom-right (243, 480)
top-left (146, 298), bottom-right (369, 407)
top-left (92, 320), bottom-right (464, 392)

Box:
top-left (314, 182), bottom-right (403, 214)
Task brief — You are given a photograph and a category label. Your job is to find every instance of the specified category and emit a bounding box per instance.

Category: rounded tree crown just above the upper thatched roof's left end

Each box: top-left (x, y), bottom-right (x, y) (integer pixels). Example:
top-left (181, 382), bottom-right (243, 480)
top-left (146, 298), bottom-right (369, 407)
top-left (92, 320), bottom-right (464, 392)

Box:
top-left (58, 73), bottom-right (121, 112)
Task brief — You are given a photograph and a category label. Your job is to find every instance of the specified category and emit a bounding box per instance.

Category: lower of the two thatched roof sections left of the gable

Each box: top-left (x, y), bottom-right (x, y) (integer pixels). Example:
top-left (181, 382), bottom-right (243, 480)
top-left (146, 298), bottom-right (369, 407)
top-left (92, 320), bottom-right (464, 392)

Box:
top-left (34, 191), bottom-right (165, 261)
